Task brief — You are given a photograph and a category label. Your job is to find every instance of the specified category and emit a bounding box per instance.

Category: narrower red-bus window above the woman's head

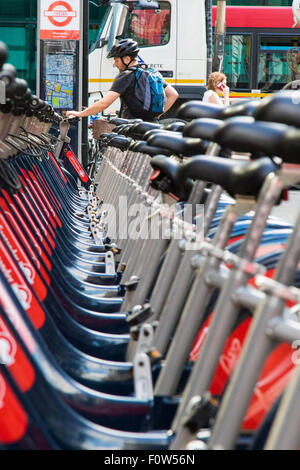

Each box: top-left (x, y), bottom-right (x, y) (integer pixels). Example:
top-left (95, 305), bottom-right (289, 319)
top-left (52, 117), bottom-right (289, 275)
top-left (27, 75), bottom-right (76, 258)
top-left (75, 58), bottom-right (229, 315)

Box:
top-left (224, 34), bottom-right (251, 90)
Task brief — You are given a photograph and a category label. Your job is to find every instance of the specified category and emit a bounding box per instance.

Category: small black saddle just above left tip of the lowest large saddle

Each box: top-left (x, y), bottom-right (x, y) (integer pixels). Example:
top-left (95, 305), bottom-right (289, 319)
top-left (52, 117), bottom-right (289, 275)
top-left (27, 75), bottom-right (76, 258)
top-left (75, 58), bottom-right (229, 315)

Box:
top-left (147, 134), bottom-right (205, 156)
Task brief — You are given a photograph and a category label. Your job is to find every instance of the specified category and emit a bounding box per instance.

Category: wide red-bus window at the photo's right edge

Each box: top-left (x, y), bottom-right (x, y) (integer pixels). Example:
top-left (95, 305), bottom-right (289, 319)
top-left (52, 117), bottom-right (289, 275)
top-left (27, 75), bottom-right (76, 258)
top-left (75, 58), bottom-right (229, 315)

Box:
top-left (258, 36), bottom-right (300, 91)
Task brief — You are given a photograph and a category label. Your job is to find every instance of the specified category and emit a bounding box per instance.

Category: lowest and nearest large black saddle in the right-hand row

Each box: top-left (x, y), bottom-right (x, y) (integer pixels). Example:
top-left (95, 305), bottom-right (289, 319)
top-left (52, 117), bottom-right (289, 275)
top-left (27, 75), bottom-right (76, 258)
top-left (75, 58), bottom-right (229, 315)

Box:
top-left (177, 155), bottom-right (277, 196)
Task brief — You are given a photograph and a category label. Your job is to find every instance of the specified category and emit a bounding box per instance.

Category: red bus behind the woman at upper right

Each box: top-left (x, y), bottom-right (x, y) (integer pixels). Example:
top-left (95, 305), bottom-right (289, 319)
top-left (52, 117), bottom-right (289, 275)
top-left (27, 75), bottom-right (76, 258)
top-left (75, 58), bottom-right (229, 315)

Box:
top-left (213, 6), bottom-right (300, 98)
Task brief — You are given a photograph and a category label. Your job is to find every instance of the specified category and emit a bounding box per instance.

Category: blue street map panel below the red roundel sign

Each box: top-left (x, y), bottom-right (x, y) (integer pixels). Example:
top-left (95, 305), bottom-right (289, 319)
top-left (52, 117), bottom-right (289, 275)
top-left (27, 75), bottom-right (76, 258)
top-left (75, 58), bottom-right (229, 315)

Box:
top-left (45, 54), bottom-right (74, 109)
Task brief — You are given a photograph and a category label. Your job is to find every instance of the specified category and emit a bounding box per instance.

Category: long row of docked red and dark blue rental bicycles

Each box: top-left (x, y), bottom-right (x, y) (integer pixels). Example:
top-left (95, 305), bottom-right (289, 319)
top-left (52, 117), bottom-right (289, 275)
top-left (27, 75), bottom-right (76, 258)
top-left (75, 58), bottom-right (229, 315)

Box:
top-left (0, 40), bottom-right (300, 451)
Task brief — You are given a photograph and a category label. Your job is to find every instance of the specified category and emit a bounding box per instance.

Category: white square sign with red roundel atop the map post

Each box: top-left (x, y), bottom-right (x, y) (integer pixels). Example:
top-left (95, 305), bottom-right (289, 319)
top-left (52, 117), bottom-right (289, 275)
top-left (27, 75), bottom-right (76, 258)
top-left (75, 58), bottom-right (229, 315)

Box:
top-left (40, 0), bottom-right (80, 39)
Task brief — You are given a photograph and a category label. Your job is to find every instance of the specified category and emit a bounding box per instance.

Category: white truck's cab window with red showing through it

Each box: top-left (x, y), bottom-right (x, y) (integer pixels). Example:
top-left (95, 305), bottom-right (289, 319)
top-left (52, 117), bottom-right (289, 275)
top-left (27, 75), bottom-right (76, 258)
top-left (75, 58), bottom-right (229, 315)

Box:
top-left (122, 2), bottom-right (171, 47)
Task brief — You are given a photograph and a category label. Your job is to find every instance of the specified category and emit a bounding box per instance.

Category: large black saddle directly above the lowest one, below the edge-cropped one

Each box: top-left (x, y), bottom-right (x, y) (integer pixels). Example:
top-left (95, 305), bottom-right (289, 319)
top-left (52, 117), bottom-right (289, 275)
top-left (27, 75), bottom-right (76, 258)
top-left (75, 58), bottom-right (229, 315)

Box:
top-left (214, 116), bottom-right (289, 157)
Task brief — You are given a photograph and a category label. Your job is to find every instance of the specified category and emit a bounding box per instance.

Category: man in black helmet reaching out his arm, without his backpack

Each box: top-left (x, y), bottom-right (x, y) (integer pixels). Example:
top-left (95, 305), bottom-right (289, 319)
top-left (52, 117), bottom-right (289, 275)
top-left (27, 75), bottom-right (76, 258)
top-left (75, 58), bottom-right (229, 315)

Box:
top-left (66, 39), bottom-right (178, 119)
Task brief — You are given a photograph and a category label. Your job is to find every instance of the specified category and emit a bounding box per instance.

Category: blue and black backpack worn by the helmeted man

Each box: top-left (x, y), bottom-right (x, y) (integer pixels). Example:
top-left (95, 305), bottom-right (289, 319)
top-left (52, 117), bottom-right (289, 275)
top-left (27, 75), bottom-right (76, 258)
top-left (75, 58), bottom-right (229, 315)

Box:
top-left (124, 65), bottom-right (165, 120)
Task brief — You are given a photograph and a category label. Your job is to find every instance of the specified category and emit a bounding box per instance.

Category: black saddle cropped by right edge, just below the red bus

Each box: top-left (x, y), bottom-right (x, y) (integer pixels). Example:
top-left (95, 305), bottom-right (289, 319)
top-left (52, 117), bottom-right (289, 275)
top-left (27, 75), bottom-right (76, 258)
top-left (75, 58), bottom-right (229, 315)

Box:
top-left (254, 91), bottom-right (300, 127)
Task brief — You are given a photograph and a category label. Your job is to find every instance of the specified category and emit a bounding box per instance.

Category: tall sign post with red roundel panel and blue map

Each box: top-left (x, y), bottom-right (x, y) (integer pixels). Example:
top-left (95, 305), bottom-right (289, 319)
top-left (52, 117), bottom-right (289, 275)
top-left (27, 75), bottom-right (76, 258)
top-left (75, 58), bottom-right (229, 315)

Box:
top-left (37, 0), bottom-right (84, 161)
